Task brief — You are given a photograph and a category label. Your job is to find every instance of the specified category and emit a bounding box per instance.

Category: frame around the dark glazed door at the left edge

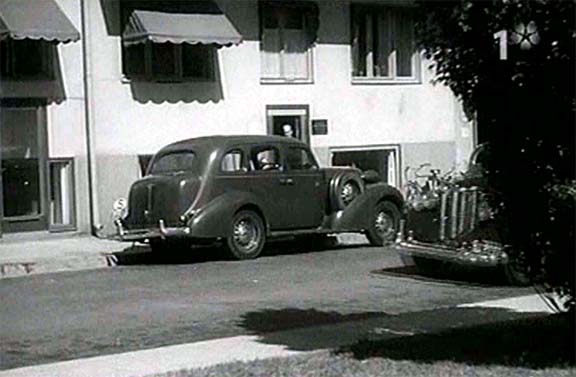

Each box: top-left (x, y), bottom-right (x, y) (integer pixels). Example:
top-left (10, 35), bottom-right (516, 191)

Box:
top-left (0, 99), bottom-right (50, 233)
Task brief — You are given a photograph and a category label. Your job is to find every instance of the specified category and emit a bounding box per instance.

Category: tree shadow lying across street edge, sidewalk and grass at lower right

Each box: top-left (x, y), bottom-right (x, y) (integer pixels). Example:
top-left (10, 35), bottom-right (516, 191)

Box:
top-left (238, 307), bottom-right (574, 368)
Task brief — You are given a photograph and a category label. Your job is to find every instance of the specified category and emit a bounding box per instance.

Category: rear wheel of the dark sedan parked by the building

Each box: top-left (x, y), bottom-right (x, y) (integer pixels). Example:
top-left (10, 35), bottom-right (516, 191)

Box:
top-left (226, 210), bottom-right (266, 259)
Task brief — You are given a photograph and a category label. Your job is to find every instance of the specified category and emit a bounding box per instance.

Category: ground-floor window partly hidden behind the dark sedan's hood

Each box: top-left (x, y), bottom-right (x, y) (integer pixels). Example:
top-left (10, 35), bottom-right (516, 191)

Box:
top-left (332, 146), bottom-right (400, 187)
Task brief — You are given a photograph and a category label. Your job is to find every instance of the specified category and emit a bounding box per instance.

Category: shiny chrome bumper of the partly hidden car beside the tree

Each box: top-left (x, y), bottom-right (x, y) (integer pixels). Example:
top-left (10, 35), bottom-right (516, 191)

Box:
top-left (393, 219), bottom-right (508, 267)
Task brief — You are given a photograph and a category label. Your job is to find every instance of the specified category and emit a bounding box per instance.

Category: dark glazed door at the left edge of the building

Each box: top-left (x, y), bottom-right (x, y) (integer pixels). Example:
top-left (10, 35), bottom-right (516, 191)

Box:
top-left (0, 105), bottom-right (47, 232)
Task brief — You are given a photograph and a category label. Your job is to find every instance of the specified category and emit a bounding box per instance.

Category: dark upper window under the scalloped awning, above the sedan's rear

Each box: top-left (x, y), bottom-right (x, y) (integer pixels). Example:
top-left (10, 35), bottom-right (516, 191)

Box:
top-left (122, 42), bottom-right (215, 82)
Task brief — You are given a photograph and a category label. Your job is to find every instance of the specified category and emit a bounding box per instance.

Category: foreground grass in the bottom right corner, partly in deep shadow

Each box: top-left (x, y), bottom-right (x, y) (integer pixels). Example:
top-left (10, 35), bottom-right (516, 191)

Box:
top-left (148, 315), bottom-right (576, 377)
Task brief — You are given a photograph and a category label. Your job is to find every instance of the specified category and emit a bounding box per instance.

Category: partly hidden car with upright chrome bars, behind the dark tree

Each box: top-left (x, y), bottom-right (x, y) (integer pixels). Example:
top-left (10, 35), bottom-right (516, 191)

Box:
top-left (394, 144), bottom-right (529, 285)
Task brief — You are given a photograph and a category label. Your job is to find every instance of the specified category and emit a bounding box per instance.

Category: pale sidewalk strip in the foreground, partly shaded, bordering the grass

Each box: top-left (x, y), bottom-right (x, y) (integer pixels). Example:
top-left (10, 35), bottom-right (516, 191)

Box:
top-left (0, 295), bottom-right (552, 377)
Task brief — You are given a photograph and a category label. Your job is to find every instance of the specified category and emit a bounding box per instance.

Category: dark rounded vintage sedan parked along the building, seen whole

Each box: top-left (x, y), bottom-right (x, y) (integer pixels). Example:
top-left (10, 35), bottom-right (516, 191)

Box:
top-left (115, 135), bottom-right (404, 259)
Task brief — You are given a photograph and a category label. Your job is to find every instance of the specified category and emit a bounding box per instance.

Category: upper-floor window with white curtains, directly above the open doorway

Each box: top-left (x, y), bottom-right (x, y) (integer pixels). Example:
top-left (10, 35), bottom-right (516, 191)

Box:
top-left (260, 1), bottom-right (317, 83)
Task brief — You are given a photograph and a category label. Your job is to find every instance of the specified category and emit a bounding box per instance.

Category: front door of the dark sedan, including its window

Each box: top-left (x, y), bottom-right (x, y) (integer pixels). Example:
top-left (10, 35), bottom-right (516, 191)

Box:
top-left (284, 144), bottom-right (326, 228)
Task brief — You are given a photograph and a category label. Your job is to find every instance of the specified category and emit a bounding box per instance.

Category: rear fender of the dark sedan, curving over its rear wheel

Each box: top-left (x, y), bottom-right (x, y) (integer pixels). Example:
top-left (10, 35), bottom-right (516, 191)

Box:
top-left (188, 191), bottom-right (267, 238)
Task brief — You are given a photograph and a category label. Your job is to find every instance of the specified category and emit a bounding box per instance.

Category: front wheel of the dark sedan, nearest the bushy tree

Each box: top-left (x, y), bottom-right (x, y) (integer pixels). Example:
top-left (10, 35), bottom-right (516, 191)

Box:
top-left (366, 201), bottom-right (400, 246)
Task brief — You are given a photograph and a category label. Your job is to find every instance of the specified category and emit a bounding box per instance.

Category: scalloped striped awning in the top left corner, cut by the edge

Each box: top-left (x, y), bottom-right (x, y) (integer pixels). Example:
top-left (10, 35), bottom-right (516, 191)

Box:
top-left (0, 0), bottom-right (80, 43)
